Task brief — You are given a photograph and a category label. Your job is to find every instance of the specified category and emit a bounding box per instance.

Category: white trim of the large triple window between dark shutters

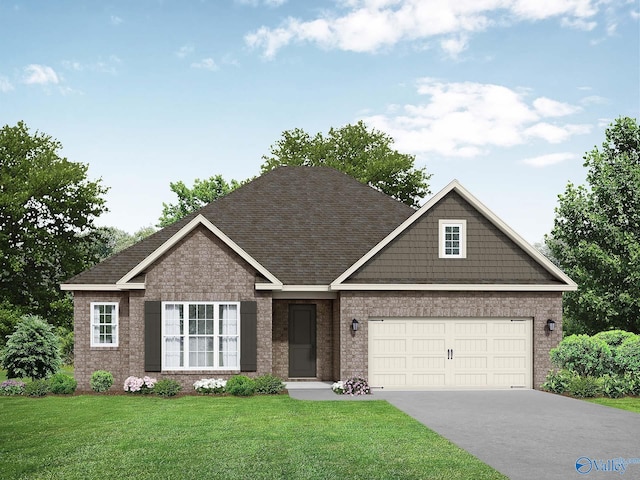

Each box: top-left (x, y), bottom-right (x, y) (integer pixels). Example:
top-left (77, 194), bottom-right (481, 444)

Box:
top-left (160, 301), bottom-right (241, 372)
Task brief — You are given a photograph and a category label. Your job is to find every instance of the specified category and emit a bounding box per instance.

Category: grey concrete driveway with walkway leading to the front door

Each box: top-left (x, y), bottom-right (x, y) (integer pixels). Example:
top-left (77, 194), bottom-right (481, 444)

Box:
top-left (289, 388), bottom-right (640, 480)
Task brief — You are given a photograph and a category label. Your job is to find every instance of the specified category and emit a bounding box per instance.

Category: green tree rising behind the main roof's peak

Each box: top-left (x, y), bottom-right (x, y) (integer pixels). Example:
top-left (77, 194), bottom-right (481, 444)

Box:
top-left (262, 121), bottom-right (431, 207)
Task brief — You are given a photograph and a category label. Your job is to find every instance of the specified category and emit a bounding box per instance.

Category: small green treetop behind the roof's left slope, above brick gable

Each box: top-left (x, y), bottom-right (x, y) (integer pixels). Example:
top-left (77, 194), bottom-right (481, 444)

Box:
top-left (157, 175), bottom-right (245, 228)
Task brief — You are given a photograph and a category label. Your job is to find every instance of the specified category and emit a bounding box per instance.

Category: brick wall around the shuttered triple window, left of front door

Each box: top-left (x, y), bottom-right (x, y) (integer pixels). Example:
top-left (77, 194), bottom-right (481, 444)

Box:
top-left (74, 227), bottom-right (272, 390)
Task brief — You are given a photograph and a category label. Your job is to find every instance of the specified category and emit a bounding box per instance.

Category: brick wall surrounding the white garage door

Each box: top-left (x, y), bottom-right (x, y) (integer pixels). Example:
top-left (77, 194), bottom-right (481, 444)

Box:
top-left (339, 292), bottom-right (562, 388)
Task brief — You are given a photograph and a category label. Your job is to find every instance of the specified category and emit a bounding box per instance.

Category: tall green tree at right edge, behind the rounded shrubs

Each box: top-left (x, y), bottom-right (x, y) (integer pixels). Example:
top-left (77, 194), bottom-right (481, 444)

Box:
top-left (546, 117), bottom-right (640, 334)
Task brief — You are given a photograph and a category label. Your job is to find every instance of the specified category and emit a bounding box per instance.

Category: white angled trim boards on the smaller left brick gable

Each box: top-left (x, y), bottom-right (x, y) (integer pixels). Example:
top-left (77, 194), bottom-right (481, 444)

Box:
top-left (116, 215), bottom-right (282, 285)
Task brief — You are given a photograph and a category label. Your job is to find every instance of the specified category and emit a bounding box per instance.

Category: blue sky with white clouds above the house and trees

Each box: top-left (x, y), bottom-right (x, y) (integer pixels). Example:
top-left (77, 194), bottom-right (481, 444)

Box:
top-left (0, 0), bottom-right (640, 243)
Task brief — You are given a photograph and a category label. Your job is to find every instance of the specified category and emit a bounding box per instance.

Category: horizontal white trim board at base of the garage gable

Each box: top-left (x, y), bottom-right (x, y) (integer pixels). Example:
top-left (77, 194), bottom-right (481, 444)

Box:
top-left (331, 283), bottom-right (578, 292)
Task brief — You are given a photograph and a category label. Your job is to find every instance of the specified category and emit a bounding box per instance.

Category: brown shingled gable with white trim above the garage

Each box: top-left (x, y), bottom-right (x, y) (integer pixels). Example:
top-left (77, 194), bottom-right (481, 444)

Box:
top-left (331, 181), bottom-right (576, 291)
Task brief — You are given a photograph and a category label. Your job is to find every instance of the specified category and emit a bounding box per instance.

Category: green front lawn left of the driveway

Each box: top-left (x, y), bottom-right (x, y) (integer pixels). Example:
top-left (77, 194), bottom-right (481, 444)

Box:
top-left (0, 395), bottom-right (505, 479)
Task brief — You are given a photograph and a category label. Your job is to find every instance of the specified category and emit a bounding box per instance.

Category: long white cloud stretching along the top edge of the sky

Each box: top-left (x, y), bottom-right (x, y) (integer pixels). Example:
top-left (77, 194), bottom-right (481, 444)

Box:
top-left (244, 0), bottom-right (599, 58)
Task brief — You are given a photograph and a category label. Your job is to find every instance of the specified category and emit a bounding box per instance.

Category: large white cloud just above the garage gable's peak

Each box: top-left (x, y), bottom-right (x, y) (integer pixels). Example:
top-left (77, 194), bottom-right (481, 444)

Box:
top-left (363, 78), bottom-right (591, 157)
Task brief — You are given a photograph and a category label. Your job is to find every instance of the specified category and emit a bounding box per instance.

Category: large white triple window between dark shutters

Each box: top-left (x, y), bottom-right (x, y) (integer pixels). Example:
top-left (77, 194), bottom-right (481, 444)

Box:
top-left (162, 302), bottom-right (240, 370)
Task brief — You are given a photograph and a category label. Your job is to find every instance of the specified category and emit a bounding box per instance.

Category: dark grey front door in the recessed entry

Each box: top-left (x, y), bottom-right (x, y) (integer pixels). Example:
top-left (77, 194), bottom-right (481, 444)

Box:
top-left (289, 305), bottom-right (316, 378)
